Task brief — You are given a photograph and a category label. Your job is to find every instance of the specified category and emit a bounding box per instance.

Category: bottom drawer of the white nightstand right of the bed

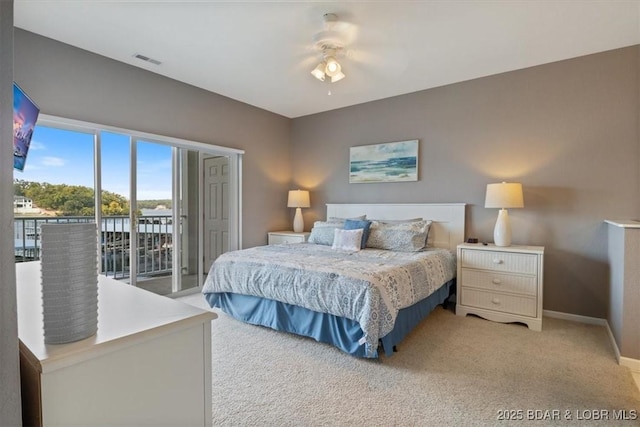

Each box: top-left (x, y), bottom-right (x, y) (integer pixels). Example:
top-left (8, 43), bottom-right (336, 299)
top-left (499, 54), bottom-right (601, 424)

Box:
top-left (460, 287), bottom-right (537, 317)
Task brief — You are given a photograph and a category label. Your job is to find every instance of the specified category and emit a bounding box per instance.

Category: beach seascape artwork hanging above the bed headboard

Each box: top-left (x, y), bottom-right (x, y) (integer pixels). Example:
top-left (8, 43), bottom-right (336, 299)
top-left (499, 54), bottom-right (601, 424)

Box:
top-left (349, 139), bottom-right (418, 184)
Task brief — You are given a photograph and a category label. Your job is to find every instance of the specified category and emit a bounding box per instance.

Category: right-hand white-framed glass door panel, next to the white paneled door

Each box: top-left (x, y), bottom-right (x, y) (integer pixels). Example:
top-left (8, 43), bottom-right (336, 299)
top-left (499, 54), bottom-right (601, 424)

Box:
top-left (131, 139), bottom-right (199, 295)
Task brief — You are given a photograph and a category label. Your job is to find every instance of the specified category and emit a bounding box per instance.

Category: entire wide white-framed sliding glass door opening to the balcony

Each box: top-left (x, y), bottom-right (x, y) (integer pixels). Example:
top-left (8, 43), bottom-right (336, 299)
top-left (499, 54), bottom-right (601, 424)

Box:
top-left (14, 115), bottom-right (242, 295)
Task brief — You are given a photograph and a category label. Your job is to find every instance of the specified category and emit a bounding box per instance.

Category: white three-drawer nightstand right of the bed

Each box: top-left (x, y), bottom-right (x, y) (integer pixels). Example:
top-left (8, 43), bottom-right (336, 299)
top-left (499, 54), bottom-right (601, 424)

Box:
top-left (456, 243), bottom-right (544, 331)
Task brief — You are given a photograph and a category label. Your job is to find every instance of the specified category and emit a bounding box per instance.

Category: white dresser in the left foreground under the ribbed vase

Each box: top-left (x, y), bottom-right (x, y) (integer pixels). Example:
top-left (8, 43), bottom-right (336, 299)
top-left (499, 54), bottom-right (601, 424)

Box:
top-left (16, 262), bottom-right (216, 426)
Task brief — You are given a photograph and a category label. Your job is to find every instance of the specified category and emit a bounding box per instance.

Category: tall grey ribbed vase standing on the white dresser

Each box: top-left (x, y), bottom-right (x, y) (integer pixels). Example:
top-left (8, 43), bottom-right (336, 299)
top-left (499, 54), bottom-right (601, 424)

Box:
top-left (40, 223), bottom-right (98, 344)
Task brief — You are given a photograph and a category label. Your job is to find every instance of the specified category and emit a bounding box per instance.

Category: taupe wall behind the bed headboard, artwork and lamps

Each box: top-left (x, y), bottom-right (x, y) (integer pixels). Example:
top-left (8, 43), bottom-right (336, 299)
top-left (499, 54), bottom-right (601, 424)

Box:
top-left (291, 46), bottom-right (640, 318)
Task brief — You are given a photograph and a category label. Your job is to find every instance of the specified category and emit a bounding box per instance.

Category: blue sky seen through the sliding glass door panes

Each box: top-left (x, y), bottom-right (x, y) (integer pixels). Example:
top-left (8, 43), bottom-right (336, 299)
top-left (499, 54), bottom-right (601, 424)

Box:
top-left (14, 126), bottom-right (171, 200)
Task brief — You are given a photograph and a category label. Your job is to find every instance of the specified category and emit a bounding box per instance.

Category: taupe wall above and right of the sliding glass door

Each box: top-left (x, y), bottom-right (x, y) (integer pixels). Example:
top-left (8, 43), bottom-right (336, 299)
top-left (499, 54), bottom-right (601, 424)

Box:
top-left (15, 29), bottom-right (291, 247)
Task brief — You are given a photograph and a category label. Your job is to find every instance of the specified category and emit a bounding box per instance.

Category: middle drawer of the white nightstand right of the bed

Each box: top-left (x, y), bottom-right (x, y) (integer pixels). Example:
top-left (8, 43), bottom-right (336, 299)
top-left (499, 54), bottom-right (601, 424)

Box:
top-left (458, 268), bottom-right (538, 297)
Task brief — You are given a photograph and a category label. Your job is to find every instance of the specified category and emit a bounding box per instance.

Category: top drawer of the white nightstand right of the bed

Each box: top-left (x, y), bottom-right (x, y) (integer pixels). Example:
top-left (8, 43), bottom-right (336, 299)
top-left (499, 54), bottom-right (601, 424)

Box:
top-left (459, 249), bottom-right (538, 275)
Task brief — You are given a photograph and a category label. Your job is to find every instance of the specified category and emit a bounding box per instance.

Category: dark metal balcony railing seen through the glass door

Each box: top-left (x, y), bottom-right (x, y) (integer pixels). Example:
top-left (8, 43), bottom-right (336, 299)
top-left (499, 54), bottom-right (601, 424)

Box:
top-left (14, 215), bottom-right (173, 279)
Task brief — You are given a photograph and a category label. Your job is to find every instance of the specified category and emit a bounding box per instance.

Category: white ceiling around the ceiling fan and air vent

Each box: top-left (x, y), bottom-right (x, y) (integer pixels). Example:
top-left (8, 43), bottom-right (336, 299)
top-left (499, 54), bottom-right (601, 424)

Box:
top-left (14, 0), bottom-right (640, 118)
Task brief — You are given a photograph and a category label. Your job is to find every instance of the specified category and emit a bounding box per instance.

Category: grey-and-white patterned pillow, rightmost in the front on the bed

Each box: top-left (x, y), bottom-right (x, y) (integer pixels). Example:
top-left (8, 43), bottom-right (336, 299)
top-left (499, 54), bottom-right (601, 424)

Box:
top-left (367, 220), bottom-right (431, 252)
